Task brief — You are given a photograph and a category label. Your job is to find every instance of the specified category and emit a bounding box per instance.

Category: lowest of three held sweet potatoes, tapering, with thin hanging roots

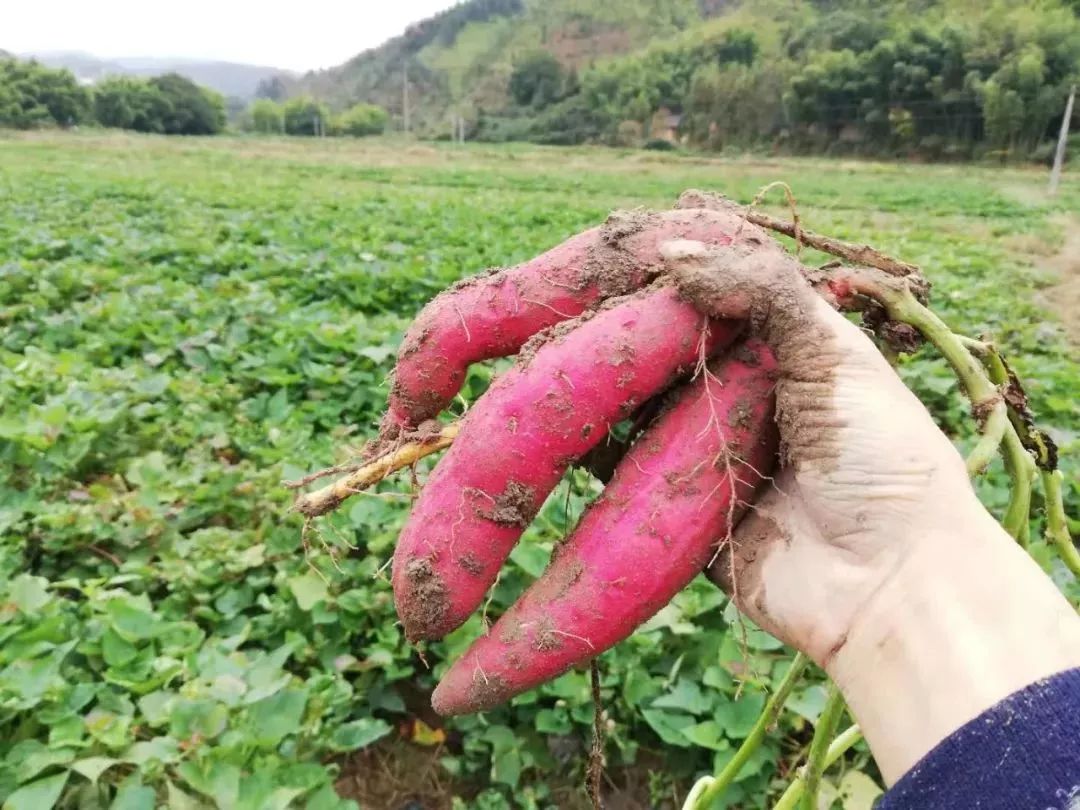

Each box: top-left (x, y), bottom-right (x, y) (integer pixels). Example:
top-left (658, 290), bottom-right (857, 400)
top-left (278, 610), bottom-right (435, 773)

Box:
top-left (432, 342), bottom-right (778, 715)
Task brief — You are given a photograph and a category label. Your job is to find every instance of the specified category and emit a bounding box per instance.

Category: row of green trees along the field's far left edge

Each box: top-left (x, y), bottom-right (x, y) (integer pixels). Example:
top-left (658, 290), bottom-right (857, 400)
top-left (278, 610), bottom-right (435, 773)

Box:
top-left (0, 58), bottom-right (388, 137)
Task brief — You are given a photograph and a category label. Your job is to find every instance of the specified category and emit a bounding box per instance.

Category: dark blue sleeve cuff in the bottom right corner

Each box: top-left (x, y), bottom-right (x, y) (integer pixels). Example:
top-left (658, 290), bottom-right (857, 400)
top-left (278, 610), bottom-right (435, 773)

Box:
top-left (876, 670), bottom-right (1080, 810)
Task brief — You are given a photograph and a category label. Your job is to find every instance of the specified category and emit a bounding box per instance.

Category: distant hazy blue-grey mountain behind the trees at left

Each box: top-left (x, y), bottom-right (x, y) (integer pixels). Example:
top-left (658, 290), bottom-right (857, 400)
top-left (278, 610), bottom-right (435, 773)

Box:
top-left (24, 51), bottom-right (288, 99)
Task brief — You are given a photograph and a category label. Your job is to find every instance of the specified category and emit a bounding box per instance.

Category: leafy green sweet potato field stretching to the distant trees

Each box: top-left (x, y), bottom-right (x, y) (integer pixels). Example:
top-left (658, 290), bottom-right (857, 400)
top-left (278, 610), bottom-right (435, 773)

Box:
top-left (0, 135), bottom-right (1080, 810)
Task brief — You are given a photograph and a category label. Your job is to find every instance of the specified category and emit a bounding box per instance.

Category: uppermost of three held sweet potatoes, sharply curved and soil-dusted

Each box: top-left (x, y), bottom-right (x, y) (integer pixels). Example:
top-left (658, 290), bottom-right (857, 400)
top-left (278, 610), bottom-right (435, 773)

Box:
top-left (383, 211), bottom-right (753, 435)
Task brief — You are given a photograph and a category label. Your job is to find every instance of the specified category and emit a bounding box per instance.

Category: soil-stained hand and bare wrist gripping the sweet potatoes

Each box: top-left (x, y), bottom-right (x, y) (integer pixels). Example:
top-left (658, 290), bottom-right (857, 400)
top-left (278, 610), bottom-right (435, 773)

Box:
top-left (662, 242), bottom-right (1080, 781)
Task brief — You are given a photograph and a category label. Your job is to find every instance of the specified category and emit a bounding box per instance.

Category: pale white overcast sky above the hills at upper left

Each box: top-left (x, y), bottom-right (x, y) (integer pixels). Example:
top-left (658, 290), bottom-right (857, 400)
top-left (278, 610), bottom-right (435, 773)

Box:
top-left (0, 0), bottom-right (456, 70)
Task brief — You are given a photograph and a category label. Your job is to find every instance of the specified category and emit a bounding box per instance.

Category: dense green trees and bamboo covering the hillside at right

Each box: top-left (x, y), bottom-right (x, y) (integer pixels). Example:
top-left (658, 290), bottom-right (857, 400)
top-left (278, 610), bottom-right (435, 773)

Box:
top-left (483, 1), bottom-right (1080, 160)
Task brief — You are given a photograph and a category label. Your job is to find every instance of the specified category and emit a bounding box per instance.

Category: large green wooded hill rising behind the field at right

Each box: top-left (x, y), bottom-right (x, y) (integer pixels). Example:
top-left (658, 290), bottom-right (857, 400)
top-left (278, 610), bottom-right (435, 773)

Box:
top-left (289, 0), bottom-right (1080, 158)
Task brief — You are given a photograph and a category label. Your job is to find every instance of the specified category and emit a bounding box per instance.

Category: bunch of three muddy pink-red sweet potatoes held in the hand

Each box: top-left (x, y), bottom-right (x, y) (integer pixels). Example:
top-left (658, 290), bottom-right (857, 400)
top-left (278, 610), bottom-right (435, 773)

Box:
top-left (382, 208), bottom-right (780, 714)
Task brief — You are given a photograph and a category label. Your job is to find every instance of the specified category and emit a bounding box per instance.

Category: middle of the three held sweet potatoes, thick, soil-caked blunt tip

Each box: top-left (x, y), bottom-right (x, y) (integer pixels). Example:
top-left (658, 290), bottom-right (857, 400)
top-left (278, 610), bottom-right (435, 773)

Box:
top-left (393, 287), bottom-right (740, 639)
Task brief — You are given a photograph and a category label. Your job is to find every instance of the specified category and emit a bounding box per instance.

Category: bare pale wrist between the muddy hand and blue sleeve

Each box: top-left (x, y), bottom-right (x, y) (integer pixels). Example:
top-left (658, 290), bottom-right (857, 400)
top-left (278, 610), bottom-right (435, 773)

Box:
top-left (826, 499), bottom-right (1080, 783)
